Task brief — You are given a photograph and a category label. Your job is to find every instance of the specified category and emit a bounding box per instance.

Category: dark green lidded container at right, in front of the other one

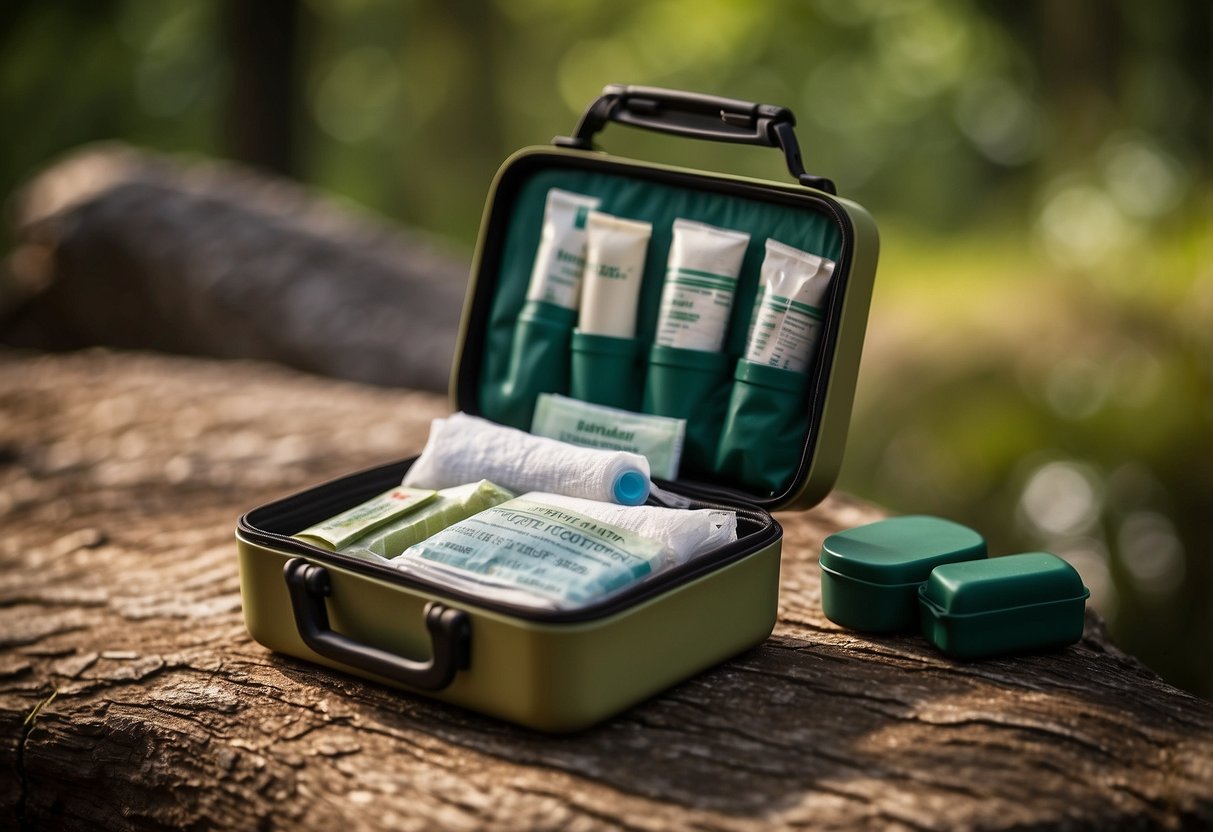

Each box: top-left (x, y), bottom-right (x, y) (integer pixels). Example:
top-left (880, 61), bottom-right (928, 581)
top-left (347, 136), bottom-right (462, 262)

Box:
top-left (918, 552), bottom-right (1090, 659)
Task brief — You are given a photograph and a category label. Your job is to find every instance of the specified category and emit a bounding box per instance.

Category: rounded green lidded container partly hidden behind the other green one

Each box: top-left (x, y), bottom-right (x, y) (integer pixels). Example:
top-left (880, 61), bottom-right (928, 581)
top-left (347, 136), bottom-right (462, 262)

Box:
top-left (820, 515), bottom-right (986, 633)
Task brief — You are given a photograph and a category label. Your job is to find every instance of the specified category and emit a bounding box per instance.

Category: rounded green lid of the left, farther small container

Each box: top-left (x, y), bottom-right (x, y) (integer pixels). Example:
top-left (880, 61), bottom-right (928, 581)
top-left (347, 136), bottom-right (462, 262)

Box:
top-left (821, 515), bottom-right (986, 586)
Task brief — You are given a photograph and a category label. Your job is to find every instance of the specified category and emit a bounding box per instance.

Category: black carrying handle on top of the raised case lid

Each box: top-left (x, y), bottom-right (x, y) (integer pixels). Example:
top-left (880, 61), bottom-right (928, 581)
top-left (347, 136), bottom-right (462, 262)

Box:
top-left (552, 84), bottom-right (838, 194)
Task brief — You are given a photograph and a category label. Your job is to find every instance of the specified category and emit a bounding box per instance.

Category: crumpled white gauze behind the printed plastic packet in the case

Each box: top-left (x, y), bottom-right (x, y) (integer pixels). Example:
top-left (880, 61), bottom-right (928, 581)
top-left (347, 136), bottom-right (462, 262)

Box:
top-left (523, 492), bottom-right (738, 566)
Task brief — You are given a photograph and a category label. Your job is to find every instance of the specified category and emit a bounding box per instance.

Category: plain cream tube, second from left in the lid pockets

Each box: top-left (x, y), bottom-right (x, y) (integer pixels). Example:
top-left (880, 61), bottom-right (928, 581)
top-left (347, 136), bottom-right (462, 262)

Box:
top-left (577, 211), bottom-right (653, 338)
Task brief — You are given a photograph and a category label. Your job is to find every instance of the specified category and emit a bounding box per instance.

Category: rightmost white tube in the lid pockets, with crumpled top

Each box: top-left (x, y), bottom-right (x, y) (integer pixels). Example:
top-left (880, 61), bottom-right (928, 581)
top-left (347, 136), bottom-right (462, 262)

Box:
top-left (746, 240), bottom-right (835, 372)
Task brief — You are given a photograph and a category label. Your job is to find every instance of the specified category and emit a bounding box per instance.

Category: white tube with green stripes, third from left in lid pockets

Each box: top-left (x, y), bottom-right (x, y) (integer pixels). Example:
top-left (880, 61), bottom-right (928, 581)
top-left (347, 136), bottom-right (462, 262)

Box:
top-left (655, 218), bottom-right (750, 353)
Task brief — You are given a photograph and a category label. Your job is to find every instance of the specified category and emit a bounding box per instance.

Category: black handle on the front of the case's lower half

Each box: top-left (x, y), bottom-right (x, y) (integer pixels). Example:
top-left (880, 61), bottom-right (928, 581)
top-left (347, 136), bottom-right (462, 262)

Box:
top-left (283, 558), bottom-right (472, 690)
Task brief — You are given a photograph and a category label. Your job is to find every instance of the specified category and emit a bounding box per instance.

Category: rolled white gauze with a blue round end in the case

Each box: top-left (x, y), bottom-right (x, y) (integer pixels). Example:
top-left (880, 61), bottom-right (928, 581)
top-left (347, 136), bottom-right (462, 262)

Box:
top-left (403, 412), bottom-right (651, 506)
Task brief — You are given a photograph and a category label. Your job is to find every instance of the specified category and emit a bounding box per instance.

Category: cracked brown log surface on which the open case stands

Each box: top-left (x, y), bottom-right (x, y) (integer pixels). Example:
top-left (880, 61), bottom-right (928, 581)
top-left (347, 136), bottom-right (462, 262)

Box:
top-left (0, 352), bottom-right (1213, 830)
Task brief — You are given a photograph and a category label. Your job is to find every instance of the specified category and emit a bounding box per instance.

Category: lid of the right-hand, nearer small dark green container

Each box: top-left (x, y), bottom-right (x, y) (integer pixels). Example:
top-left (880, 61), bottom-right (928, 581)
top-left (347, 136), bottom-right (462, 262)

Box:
top-left (918, 552), bottom-right (1090, 615)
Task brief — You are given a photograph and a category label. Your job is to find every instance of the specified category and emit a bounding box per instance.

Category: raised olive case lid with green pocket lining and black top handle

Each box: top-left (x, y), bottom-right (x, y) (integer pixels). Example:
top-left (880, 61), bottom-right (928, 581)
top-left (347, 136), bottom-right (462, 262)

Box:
top-left (451, 86), bottom-right (878, 511)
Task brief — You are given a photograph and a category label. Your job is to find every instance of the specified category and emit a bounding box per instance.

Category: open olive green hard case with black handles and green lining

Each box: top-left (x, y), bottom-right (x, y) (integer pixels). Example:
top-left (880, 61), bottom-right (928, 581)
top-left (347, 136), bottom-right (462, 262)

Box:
top-left (237, 86), bottom-right (877, 731)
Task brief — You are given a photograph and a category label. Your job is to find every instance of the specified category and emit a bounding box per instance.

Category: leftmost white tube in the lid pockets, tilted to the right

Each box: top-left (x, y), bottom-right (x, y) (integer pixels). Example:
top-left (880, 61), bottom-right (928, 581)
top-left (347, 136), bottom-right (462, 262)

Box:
top-left (526, 188), bottom-right (602, 309)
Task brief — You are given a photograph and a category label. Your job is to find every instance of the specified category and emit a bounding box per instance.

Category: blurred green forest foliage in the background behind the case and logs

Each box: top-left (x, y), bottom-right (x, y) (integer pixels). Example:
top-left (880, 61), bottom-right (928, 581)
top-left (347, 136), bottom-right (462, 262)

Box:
top-left (0, 0), bottom-right (1213, 695)
